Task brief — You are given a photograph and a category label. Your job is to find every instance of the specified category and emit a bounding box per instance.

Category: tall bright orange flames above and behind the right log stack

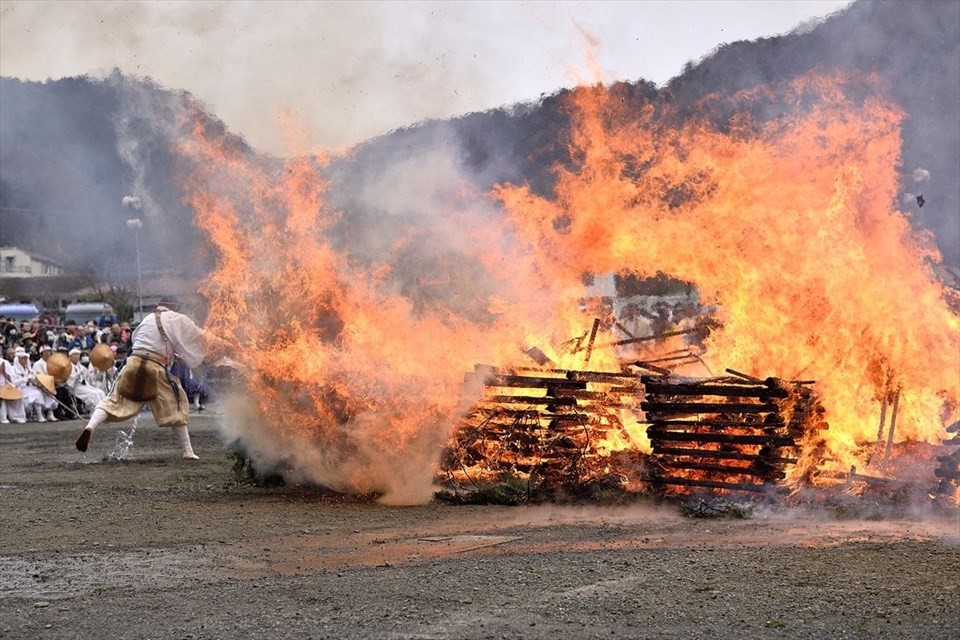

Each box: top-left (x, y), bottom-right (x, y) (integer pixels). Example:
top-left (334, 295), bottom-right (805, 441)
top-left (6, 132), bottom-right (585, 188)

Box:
top-left (498, 76), bottom-right (960, 468)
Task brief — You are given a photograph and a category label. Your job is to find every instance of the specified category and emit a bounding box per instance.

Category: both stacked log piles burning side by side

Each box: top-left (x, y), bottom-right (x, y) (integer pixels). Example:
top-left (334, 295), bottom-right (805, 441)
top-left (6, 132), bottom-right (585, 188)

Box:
top-left (443, 366), bottom-right (827, 500)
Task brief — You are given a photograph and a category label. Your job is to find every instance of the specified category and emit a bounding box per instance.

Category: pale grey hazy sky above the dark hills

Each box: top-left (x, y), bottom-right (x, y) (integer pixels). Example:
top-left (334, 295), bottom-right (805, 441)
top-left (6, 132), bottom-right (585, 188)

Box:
top-left (0, 0), bottom-right (850, 154)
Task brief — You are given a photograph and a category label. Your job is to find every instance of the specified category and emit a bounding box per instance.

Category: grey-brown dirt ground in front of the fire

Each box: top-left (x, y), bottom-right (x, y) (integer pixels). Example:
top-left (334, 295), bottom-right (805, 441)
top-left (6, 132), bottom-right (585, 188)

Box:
top-left (0, 413), bottom-right (960, 640)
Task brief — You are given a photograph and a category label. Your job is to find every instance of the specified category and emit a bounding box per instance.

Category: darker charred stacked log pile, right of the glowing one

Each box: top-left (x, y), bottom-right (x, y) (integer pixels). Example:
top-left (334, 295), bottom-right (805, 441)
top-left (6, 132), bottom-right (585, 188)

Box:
top-left (640, 370), bottom-right (827, 493)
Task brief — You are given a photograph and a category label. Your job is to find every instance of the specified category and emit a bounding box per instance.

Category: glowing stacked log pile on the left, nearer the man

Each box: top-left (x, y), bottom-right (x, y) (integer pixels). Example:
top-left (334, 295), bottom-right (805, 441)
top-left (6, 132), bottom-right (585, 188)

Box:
top-left (442, 365), bottom-right (640, 486)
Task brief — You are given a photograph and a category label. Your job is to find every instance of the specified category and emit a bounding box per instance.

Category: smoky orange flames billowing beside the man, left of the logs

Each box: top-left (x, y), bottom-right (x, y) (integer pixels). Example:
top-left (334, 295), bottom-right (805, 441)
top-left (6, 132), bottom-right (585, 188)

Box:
top-left (177, 104), bottom-right (557, 504)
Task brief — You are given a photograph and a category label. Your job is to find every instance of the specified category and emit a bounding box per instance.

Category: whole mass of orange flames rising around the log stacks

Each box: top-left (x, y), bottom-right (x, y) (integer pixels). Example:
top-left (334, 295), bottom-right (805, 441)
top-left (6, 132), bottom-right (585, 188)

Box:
top-left (177, 75), bottom-right (960, 502)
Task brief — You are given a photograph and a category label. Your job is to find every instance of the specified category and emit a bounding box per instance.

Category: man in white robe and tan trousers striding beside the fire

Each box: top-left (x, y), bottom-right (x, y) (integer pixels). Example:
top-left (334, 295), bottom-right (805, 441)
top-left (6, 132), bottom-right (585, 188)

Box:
top-left (77, 298), bottom-right (222, 460)
